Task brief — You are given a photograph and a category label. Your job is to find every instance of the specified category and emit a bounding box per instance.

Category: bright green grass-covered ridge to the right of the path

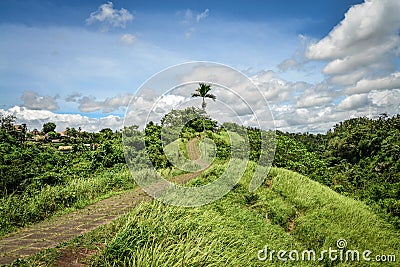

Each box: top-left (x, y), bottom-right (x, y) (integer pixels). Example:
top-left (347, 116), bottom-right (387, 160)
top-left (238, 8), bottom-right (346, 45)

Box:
top-left (89, 164), bottom-right (400, 266)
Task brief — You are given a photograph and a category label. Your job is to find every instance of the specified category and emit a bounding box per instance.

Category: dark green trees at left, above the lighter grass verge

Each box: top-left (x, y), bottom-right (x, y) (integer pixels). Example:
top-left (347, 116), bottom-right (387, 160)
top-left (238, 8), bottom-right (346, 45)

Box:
top-left (0, 116), bottom-right (125, 196)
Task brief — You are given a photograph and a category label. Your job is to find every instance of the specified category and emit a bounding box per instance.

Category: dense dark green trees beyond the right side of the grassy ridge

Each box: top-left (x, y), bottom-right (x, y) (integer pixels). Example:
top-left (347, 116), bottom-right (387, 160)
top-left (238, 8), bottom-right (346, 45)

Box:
top-left (277, 115), bottom-right (400, 228)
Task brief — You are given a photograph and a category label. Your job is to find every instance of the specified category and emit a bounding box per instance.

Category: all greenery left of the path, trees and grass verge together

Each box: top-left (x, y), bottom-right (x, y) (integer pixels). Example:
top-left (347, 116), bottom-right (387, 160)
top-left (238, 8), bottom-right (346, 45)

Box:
top-left (0, 116), bottom-right (127, 235)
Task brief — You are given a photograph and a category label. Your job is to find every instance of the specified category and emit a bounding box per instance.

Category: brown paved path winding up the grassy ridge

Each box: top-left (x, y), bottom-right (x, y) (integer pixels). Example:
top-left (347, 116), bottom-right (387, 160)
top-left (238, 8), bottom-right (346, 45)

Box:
top-left (0, 139), bottom-right (204, 265)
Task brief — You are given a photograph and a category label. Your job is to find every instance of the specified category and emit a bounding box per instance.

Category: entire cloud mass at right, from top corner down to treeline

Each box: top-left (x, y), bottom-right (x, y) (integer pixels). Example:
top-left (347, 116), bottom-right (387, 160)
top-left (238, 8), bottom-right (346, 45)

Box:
top-left (284, 0), bottom-right (400, 132)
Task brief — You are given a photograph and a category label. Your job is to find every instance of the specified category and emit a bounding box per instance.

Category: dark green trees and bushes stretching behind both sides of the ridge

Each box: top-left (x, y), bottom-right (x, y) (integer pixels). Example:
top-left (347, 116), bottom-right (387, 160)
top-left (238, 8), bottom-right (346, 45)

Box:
top-left (0, 108), bottom-right (400, 240)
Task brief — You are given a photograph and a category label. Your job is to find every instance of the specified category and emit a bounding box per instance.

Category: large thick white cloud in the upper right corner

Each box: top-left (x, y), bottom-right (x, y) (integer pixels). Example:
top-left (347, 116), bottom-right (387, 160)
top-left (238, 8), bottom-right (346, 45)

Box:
top-left (307, 0), bottom-right (400, 60)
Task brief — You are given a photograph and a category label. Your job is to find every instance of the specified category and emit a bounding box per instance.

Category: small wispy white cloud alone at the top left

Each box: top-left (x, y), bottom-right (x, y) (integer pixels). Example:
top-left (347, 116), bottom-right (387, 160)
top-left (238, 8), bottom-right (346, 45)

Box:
top-left (86, 2), bottom-right (134, 28)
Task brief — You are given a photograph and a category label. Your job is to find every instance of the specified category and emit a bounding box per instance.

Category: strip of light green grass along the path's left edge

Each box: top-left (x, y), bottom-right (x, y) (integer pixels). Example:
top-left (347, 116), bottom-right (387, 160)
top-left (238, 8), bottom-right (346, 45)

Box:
top-left (0, 165), bottom-right (136, 236)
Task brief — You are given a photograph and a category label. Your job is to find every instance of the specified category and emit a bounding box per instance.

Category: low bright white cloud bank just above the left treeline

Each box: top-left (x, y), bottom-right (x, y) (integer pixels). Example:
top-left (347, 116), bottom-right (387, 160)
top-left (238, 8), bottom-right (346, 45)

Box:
top-left (0, 106), bottom-right (123, 132)
